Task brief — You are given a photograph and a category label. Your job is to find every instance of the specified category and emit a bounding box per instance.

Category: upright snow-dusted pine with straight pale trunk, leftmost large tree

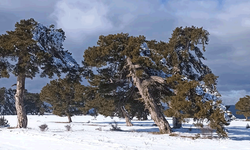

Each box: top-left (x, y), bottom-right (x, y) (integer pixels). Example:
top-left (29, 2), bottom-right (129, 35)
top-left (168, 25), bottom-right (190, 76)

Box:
top-left (0, 18), bottom-right (78, 128)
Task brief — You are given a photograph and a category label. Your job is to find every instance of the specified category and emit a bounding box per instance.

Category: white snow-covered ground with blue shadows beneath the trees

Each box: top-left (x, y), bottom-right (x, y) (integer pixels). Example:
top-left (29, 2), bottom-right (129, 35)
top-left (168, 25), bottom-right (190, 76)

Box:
top-left (0, 115), bottom-right (250, 150)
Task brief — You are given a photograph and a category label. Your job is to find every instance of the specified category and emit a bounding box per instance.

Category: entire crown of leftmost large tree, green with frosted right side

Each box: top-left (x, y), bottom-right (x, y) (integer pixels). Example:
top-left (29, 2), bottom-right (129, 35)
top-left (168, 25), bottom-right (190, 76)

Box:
top-left (0, 18), bottom-right (79, 78)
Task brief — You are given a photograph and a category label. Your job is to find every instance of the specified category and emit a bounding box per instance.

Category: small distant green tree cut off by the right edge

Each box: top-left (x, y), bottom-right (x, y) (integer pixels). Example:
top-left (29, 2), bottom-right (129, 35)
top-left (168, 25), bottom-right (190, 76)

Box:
top-left (235, 95), bottom-right (250, 120)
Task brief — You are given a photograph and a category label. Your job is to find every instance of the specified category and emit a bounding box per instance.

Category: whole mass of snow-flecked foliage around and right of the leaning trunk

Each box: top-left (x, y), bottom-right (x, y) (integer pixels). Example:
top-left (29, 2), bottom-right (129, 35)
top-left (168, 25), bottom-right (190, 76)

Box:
top-left (83, 26), bottom-right (226, 136)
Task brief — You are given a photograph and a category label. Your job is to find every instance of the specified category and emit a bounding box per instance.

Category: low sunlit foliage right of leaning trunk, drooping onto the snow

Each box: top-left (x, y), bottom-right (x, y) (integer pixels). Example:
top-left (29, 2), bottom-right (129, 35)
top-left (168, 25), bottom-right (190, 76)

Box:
top-left (164, 74), bottom-right (228, 137)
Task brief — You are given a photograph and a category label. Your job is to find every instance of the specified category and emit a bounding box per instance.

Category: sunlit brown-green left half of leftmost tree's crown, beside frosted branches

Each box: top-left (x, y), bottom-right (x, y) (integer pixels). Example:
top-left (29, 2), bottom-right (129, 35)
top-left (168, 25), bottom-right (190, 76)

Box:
top-left (0, 19), bottom-right (39, 78)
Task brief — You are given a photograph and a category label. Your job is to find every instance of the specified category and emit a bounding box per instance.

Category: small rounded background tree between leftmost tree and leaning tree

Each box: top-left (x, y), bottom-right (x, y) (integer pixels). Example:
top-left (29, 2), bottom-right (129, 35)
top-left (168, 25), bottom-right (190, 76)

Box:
top-left (40, 78), bottom-right (85, 122)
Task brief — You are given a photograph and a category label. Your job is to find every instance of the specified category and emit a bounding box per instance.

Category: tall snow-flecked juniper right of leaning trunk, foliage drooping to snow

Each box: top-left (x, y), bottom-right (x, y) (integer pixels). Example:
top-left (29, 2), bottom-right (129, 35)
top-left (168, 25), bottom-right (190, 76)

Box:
top-left (158, 27), bottom-right (227, 136)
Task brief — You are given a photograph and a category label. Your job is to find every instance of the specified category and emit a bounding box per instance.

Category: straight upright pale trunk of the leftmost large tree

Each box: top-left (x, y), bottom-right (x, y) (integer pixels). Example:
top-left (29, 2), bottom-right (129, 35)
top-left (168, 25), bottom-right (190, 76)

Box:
top-left (15, 74), bottom-right (28, 128)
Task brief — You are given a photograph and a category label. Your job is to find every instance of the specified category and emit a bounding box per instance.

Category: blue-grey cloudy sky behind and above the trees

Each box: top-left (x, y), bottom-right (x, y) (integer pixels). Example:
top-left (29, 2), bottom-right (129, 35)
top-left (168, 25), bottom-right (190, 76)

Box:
top-left (0, 0), bottom-right (250, 104)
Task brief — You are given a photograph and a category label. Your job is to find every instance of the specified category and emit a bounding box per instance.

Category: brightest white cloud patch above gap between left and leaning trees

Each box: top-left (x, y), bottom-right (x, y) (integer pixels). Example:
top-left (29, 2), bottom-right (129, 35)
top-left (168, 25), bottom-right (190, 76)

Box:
top-left (51, 0), bottom-right (113, 41)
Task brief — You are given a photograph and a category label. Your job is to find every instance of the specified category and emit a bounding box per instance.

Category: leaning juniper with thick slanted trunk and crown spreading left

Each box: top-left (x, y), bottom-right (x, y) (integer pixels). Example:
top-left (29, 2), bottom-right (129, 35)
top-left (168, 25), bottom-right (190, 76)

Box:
top-left (84, 33), bottom-right (175, 133)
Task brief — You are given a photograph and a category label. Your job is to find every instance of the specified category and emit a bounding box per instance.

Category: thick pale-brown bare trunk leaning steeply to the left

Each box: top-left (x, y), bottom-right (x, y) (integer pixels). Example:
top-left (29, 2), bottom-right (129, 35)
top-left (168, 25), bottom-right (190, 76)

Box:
top-left (127, 57), bottom-right (171, 134)
